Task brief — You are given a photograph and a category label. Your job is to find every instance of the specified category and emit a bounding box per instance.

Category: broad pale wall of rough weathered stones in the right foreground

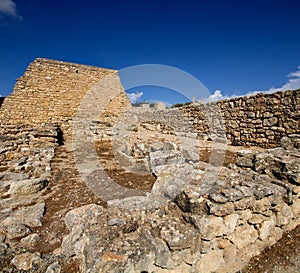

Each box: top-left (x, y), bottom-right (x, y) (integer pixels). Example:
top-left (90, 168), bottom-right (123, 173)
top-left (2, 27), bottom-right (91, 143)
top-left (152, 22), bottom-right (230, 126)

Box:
top-left (62, 133), bottom-right (300, 272)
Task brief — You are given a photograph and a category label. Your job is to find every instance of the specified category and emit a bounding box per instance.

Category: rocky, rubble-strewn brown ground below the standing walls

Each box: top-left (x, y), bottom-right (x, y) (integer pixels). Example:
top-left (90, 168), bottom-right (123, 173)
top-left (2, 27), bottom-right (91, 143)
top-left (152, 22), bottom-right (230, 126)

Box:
top-left (0, 122), bottom-right (300, 273)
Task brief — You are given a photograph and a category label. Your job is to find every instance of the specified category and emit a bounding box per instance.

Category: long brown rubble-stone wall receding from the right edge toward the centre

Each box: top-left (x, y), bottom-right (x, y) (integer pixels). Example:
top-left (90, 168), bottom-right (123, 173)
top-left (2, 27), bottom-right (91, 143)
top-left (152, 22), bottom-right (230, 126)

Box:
top-left (95, 90), bottom-right (300, 148)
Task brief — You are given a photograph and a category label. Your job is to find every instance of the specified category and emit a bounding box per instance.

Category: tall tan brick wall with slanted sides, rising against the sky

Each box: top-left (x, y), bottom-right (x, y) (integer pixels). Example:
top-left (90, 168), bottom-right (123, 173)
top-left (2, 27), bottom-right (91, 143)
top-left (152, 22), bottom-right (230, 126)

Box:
top-left (0, 58), bottom-right (130, 138)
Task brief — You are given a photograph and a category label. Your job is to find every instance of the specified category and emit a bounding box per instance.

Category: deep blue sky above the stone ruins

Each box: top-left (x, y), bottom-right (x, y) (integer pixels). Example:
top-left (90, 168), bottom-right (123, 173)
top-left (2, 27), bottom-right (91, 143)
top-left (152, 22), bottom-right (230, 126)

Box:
top-left (0, 0), bottom-right (300, 103)
